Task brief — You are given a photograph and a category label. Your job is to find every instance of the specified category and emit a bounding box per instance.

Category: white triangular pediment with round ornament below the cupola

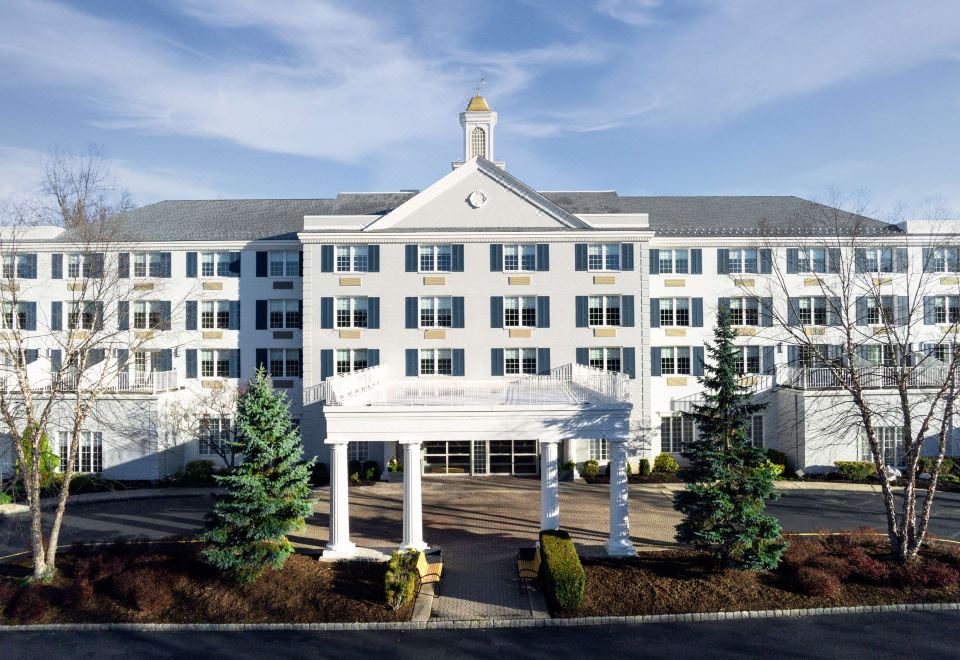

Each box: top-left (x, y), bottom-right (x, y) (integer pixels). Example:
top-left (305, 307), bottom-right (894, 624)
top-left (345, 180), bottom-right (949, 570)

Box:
top-left (364, 158), bottom-right (589, 231)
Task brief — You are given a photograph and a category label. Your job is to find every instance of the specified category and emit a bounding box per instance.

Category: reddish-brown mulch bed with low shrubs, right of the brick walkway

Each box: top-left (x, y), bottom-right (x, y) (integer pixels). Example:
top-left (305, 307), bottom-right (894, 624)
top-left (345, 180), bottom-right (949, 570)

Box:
top-left (558, 533), bottom-right (960, 616)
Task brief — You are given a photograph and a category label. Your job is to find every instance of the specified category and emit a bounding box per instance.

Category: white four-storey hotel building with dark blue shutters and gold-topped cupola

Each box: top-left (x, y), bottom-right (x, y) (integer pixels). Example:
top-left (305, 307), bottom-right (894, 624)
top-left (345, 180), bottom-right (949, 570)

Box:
top-left (0, 97), bottom-right (957, 554)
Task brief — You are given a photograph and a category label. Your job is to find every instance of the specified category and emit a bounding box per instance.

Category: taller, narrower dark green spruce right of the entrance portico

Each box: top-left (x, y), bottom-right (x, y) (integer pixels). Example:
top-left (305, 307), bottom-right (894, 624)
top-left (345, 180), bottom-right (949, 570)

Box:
top-left (674, 310), bottom-right (786, 570)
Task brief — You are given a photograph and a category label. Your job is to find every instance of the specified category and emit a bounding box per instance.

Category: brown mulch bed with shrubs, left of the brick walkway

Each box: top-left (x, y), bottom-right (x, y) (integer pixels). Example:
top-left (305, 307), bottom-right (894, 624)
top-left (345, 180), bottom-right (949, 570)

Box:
top-left (0, 543), bottom-right (413, 624)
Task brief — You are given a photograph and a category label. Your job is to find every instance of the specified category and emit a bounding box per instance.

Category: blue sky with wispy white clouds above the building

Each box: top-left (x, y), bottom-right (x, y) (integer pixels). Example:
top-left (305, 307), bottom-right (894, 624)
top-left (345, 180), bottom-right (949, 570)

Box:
top-left (0, 0), bottom-right (960, 217)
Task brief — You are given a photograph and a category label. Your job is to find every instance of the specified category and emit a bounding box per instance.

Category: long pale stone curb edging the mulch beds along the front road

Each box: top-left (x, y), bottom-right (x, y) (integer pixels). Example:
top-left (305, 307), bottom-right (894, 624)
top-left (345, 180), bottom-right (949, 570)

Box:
top-left (0, 603), bottom-right (960, 633)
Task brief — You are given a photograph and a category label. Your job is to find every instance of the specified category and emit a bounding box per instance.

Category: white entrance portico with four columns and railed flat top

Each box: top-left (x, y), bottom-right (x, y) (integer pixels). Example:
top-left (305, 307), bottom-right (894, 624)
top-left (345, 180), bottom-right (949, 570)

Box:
top-left (313, 365), bottom-right (633, 559)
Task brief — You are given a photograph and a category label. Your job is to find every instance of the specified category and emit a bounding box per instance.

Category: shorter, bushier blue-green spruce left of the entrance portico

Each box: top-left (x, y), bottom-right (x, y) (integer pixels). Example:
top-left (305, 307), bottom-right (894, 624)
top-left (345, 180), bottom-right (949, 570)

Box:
top-left (203, 369), bottom-right (315, 582)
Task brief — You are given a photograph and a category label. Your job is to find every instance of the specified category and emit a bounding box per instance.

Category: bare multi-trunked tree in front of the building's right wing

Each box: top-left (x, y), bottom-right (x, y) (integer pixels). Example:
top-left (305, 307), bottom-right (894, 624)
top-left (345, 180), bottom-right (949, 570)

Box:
top-left (741, 198), bottom-right (960, 562)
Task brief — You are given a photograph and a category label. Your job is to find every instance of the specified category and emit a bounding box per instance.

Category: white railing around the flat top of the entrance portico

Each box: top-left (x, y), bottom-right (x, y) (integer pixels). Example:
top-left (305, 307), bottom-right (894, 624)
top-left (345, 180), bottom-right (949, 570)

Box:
top-left (304, 364), bottom-right (630, 406)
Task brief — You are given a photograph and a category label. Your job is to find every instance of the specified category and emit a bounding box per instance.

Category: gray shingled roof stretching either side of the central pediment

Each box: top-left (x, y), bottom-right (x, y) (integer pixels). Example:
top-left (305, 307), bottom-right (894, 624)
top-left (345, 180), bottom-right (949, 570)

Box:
top-left (59, 191), bottom-right (899, 242)
